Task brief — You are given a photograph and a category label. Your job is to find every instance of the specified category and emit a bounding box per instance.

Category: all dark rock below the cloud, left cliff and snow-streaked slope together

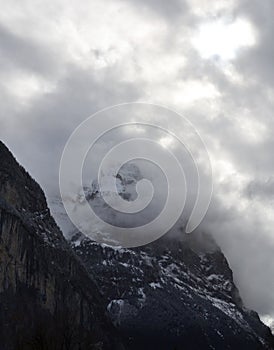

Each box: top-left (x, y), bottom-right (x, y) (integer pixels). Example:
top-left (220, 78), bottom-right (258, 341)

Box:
top-left (0, 142), bottom-right (274, 350)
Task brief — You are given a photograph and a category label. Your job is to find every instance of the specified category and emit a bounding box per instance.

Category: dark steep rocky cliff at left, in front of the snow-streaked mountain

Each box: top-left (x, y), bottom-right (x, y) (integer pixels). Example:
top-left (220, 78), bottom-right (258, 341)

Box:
top-left (0, 142), bottom-right (122, 350)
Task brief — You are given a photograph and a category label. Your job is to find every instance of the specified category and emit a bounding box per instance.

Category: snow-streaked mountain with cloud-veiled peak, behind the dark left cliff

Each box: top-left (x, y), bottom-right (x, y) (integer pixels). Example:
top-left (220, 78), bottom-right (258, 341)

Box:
top-left (53, 165), bottom-right (274, 350)
